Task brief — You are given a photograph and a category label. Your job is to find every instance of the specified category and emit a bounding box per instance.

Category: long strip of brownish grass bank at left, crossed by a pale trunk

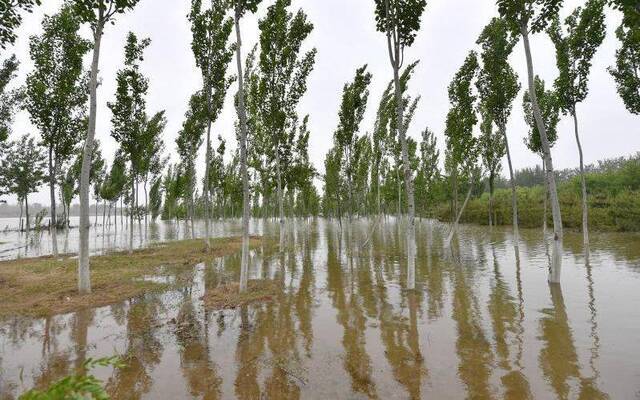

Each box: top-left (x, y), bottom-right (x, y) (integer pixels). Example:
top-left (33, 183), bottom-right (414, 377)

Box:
top-left (0, 238), bottom-right (257, 316)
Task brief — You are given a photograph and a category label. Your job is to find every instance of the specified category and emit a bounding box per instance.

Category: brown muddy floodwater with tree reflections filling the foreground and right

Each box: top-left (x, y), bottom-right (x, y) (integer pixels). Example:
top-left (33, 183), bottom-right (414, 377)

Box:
top-left (0, 220), bottom-right (640, 399)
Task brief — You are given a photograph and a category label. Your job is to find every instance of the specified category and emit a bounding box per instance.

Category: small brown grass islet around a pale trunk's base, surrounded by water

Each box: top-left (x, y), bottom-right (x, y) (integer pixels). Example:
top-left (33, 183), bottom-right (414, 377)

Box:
top-left (203, 279), bottom-right (278, 309)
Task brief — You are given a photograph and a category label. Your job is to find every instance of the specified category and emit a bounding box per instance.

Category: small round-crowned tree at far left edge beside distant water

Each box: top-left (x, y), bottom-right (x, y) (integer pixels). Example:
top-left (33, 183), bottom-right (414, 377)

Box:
top-left (1, 135), bottom-right (47, 232)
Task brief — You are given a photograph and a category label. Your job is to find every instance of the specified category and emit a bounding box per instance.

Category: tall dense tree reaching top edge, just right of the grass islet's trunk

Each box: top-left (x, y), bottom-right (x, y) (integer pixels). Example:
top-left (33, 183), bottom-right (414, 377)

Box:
top-left (259, 0), bottom-right (316, 250)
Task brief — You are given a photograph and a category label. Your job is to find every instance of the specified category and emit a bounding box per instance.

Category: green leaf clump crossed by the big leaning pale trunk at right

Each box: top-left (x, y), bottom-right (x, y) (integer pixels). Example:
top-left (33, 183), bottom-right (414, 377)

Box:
top-left (522, 76), bottom-right (560, 155)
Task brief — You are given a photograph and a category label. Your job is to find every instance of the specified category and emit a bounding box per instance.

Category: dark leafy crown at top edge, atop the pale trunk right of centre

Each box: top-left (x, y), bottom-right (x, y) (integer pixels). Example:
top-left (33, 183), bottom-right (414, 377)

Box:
top-left (374, 0), bottom-right (427, 48)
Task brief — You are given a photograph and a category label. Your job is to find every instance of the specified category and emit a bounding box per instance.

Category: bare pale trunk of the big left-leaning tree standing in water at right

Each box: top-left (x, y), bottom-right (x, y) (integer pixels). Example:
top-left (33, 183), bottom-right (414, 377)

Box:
top-left (521, 26), bottom-right (562, 282)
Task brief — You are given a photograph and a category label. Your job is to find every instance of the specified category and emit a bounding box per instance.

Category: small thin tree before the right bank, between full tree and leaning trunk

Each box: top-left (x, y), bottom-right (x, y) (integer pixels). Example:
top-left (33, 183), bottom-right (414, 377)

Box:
top-left (478, 108), bottom-right (504, 226)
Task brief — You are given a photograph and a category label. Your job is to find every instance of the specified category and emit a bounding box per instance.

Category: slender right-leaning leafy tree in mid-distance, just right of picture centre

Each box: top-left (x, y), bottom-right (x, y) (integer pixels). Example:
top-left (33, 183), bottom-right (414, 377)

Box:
top-left (333, 65), bottom-right (371, 218)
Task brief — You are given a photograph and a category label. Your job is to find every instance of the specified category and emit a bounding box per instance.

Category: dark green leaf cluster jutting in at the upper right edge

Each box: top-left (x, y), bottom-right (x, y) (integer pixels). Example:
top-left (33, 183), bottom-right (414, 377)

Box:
top-left (609, 23), bottom-right (640, 115)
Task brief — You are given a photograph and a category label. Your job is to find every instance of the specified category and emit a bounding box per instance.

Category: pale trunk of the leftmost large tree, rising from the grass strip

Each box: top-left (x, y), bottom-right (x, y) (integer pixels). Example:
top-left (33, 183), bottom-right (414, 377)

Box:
top-left (78, 16), bottom-right (104, 293)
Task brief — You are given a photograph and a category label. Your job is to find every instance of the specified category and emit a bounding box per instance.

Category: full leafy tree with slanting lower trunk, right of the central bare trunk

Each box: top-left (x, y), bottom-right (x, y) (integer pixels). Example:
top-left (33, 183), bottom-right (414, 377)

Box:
top-left (444, 51), bottom-right (479, 245)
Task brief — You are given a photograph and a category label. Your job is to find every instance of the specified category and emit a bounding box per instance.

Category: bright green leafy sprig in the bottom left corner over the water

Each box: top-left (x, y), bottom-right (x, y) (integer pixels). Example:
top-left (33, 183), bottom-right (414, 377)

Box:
top-left (20, 357), bottom-right (124, 400)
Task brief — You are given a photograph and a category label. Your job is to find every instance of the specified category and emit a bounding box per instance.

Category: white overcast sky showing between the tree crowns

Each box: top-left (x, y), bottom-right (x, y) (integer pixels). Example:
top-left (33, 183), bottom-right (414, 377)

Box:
top-left (1, 0), bottom-right (640, 204)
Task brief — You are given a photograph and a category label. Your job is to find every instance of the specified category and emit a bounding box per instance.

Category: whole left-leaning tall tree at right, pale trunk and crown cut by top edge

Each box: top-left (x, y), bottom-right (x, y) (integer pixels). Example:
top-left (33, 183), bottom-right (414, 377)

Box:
top-left (497, 0), bottom-right (562, 268)
